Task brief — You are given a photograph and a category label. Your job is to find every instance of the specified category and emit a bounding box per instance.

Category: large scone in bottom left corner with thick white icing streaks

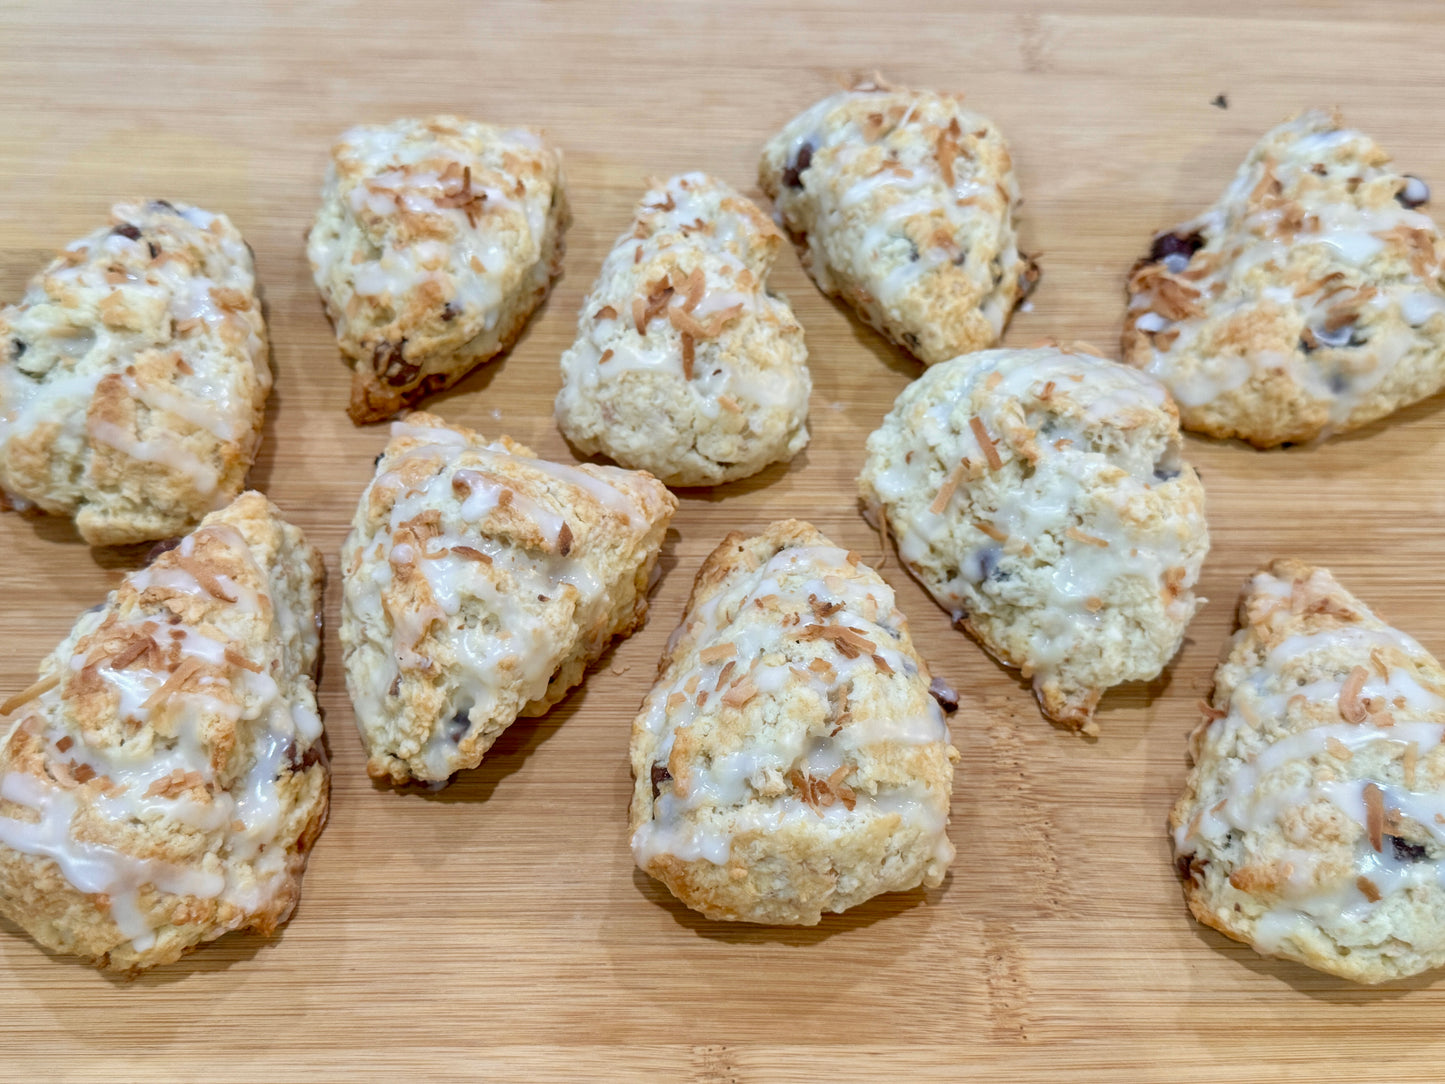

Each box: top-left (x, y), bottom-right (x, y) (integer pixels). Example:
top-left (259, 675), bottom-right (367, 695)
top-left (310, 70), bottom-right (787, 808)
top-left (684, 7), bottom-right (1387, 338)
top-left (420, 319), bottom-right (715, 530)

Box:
top-left (0, 493), bottom-right (329, 971)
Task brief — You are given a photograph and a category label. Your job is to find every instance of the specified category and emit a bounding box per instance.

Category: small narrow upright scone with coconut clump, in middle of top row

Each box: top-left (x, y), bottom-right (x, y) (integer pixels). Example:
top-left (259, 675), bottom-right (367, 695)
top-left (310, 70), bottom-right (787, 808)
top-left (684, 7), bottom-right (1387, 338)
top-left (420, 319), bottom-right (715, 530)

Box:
top-left (556, 173), bottom-right (812, 486)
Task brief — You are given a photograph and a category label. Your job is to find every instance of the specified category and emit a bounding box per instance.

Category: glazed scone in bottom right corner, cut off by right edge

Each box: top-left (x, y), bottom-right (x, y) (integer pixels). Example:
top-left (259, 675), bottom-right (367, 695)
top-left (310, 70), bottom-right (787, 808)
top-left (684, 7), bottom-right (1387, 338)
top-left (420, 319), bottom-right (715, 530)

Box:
top-left (1169, 559), bottom-right (1445, 983)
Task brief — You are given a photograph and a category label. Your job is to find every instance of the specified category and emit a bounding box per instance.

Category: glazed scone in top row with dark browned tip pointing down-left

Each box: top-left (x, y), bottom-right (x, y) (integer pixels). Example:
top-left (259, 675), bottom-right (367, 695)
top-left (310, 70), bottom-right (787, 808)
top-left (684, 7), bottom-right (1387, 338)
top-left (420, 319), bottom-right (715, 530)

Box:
top-left (306, 116), bottom-right (568, 423)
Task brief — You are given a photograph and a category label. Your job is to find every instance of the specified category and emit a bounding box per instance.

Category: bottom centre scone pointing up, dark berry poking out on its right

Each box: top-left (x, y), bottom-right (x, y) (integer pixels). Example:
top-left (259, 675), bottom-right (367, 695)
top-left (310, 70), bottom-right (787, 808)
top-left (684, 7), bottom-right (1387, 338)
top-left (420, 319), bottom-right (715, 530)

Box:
top-left (630, 520), bottom-right (958, 925)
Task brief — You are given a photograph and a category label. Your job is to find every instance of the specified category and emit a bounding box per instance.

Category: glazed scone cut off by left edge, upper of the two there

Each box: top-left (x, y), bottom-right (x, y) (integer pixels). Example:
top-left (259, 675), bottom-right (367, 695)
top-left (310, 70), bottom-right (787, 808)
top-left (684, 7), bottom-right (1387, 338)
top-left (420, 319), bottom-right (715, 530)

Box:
top-left (0, 199), bottom-right (272, 545)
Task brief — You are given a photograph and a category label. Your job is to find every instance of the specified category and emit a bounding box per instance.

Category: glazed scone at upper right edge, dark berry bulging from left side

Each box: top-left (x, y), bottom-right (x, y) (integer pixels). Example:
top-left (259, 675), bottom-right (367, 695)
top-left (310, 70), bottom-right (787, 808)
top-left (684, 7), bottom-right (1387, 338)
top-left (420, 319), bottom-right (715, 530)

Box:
top-left (1123, 111), bottom-right (1445, 448)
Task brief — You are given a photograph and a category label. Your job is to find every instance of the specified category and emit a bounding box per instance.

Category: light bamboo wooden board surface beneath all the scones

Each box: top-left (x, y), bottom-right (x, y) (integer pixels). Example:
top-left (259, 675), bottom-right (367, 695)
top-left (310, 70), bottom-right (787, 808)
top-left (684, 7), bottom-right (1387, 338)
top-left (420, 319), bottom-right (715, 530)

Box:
top-left (0, 0), bottom-right (1445, 1083)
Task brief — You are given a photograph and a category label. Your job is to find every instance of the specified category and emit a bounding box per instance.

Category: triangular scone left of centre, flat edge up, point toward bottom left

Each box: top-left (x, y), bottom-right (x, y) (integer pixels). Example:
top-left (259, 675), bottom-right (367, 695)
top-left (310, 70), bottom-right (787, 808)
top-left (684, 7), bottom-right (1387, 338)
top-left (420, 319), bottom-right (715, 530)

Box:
top-left (341, 413), bottom-right (678, 782)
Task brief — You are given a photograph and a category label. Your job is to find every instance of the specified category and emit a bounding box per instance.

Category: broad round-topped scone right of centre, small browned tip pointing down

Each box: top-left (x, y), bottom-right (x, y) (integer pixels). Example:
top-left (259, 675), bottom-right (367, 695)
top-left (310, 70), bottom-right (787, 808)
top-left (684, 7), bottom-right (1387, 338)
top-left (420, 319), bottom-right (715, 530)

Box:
top-left (858, 345), bottom-right (1209, 734)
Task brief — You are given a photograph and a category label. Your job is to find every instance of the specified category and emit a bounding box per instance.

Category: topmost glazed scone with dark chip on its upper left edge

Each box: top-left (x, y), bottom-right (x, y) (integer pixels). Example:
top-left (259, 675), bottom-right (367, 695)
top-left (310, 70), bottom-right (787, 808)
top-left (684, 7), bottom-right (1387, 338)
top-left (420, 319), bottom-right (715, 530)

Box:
top-left (757, 81), bottom-right (1039, 366)
